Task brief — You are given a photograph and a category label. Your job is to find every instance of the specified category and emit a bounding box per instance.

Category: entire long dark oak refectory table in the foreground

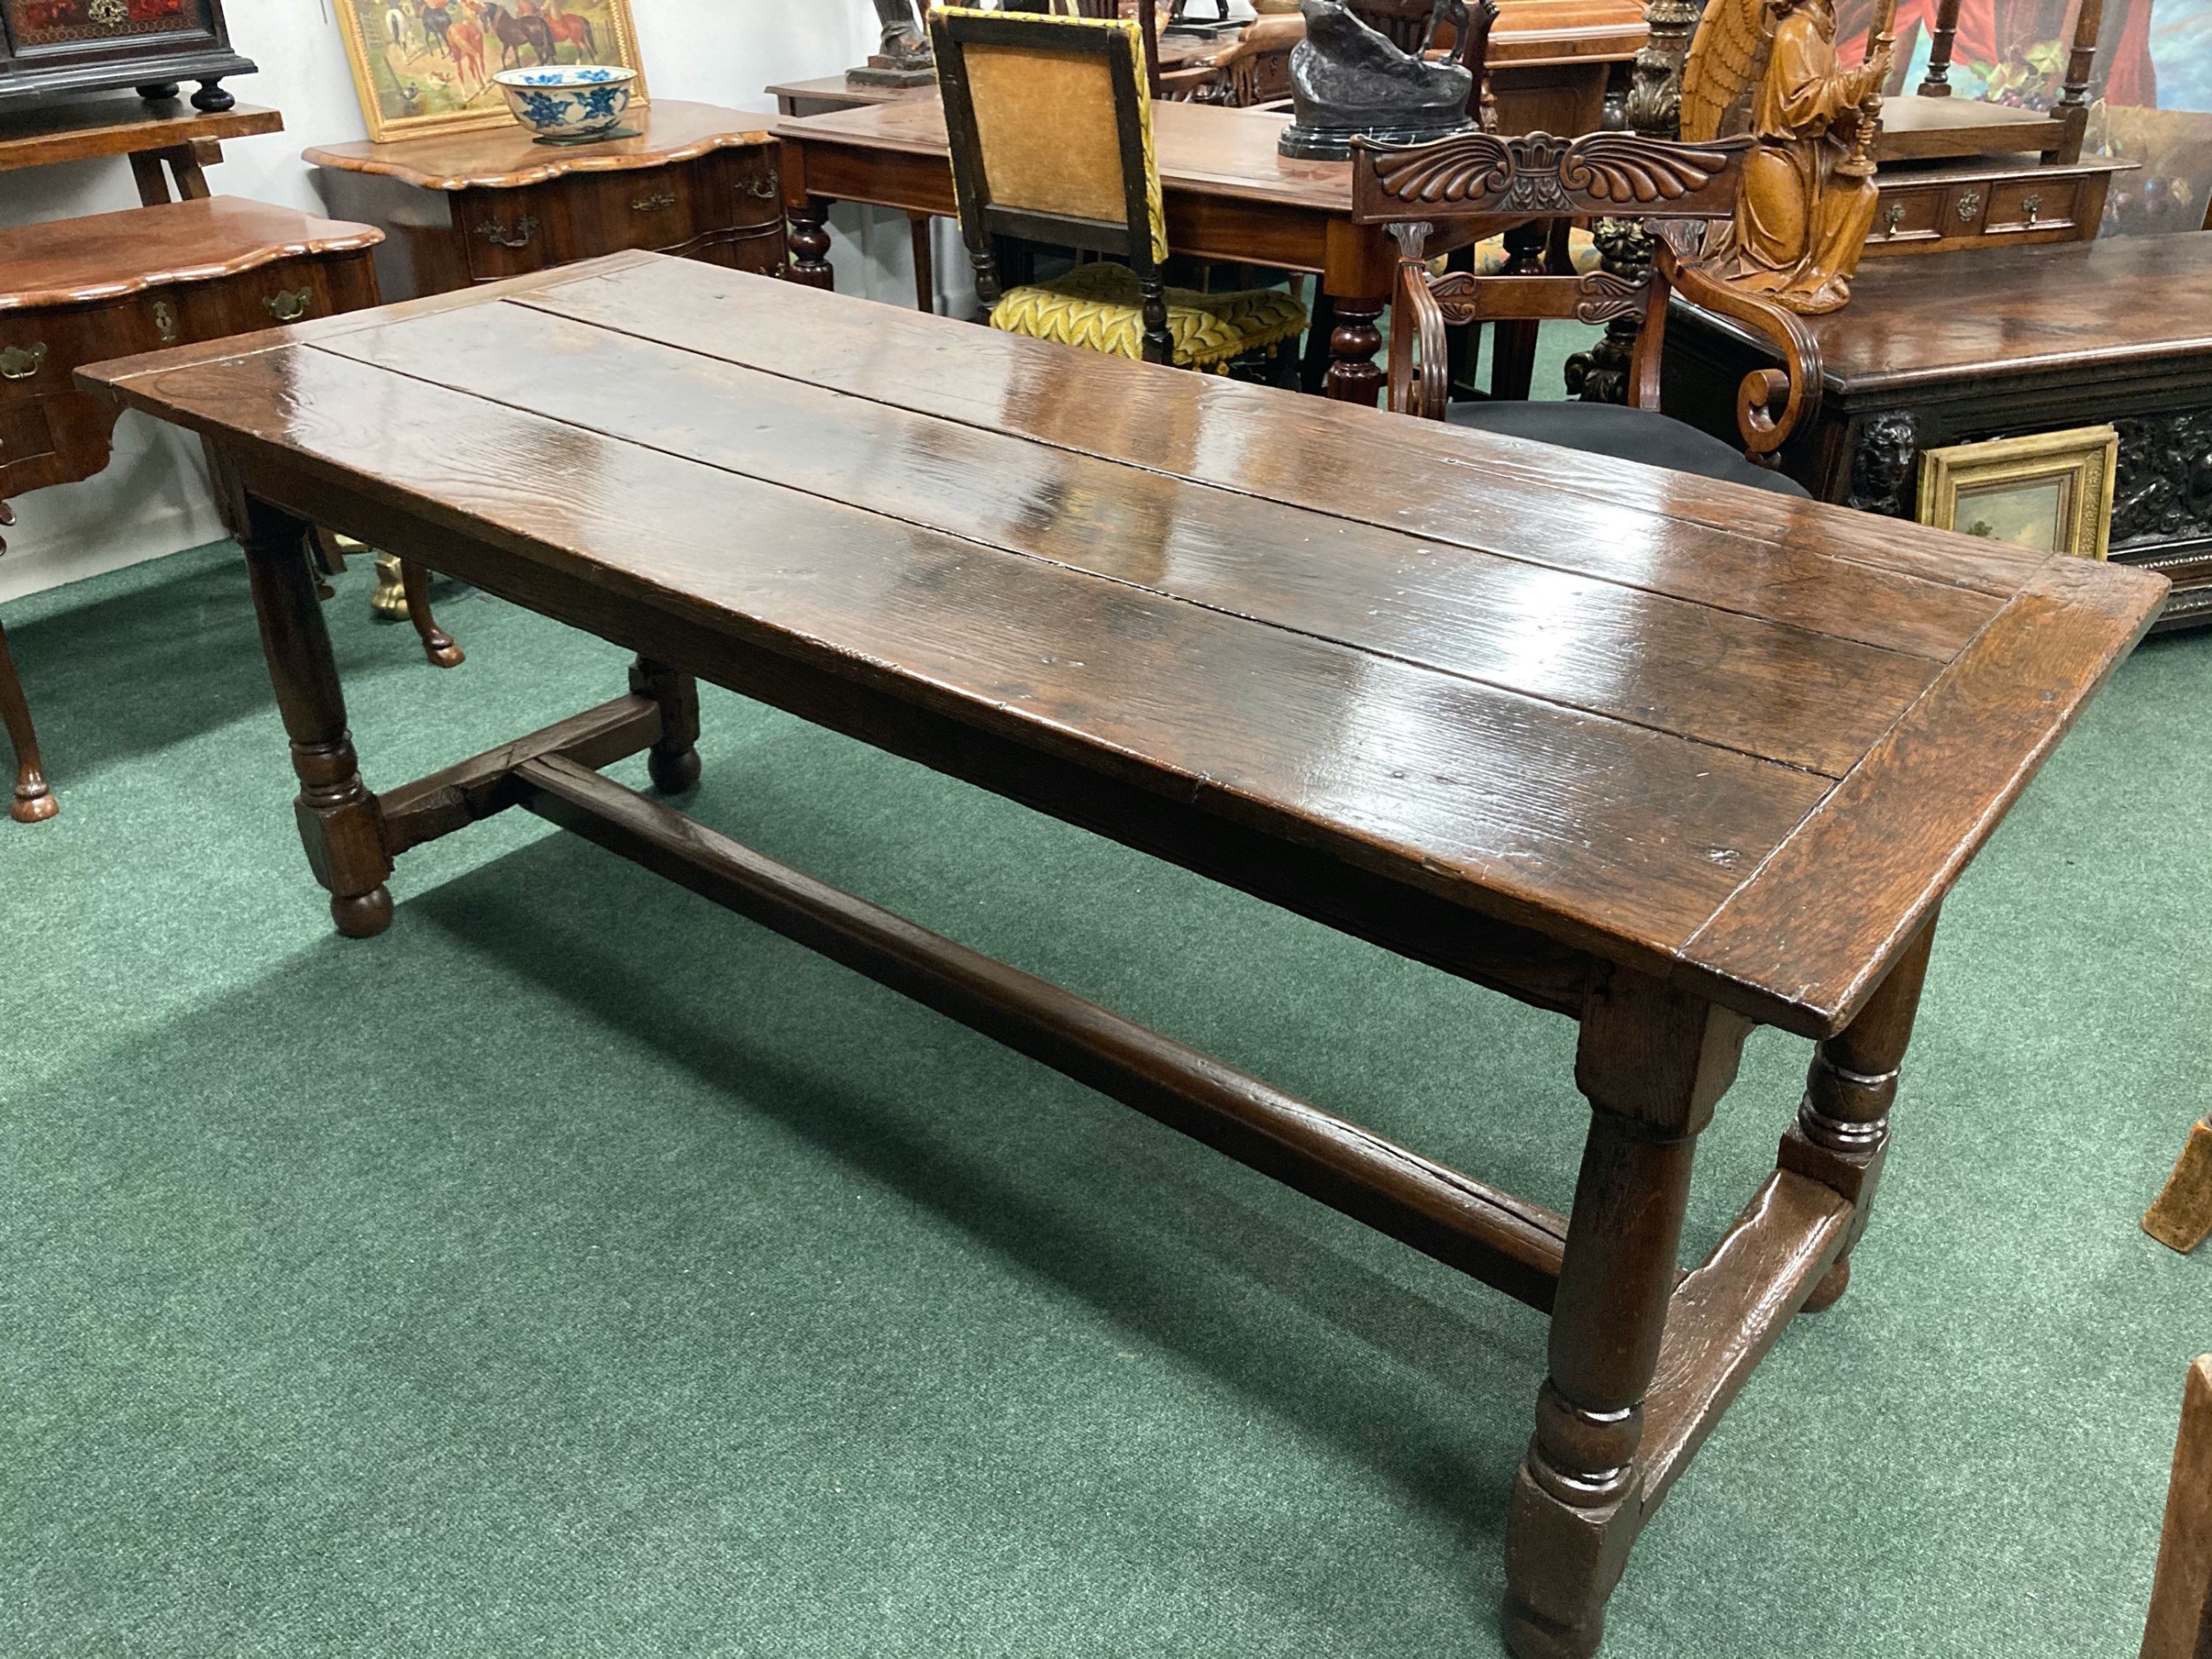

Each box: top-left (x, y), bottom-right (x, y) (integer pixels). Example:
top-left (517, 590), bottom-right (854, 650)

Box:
top-left (84, 255), bottom-right (2166, 1659)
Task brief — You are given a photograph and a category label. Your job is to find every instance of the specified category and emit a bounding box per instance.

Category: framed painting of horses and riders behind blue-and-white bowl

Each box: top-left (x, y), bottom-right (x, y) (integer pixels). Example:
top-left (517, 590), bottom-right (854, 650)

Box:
top-left (330, 0), bottom-right (646, 144)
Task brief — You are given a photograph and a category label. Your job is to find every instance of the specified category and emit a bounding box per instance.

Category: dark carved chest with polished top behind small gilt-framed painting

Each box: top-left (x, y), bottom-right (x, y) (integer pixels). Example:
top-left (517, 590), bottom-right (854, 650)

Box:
top-left (1666, 234), bottom-right (2212, 628)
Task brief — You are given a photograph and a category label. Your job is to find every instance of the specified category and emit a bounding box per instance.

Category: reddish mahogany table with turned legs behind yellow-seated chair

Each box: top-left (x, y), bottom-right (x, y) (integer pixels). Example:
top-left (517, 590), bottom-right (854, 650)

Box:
top-left (774, 97), bottom-right (1396, 403)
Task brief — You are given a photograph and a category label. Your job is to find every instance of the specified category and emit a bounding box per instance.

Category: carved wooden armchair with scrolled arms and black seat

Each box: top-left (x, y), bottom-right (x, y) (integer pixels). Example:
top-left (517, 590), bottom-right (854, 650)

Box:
top-left (1352, 133), bottom-right (1821, 495)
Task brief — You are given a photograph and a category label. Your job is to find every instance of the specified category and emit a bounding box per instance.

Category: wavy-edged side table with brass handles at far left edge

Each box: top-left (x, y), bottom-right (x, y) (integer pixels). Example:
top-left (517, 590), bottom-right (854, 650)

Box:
top-left (0, 197), bottom-right (460, 823)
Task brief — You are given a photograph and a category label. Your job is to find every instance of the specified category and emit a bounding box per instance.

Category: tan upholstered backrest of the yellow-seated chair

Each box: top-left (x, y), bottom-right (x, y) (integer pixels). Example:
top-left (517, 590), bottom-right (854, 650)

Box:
top-left (929, 7), bottom-right (1168, 305)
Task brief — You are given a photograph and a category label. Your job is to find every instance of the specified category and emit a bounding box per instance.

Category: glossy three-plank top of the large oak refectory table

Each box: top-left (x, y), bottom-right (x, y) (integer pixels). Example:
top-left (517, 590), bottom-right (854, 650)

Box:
top-left (84, 255), bottom-right (2166, 1035)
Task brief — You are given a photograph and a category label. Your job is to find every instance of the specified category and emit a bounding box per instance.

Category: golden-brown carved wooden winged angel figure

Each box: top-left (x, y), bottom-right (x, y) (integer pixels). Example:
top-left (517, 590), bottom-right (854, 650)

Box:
top-left (1681, 0), bottom-right (1889, 317)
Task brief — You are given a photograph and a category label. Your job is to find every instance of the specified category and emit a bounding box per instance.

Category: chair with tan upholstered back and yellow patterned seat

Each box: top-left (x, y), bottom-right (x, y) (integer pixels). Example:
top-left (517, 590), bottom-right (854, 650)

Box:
top-left (929, 9), bottom-right (1305, 374)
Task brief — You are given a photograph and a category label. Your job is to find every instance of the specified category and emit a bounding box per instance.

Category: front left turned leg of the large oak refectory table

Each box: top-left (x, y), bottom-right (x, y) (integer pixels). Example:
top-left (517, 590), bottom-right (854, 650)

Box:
top-left (239, 503), bottom-right (392, 938)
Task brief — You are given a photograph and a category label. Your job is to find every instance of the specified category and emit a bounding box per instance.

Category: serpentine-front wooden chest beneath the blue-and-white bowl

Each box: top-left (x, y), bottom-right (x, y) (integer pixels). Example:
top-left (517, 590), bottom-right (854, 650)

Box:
top-left (305, 100), bottom-right (783, 301)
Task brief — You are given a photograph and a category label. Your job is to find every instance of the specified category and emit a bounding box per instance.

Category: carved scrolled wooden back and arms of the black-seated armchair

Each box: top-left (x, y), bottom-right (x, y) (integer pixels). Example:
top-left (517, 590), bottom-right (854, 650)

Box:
top-left (1352, 133), bottom-right (1821, 456)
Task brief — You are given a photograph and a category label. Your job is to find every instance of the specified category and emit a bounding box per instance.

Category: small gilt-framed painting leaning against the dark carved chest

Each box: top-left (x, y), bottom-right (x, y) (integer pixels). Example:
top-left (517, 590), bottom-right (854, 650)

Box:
top-left (1920, 427), bottom-right (2119, 560)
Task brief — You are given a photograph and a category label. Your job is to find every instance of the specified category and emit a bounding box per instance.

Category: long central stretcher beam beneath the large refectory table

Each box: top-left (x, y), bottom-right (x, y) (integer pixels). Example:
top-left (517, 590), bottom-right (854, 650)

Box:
top-left (513, 755), bottom-right (1566, 1312)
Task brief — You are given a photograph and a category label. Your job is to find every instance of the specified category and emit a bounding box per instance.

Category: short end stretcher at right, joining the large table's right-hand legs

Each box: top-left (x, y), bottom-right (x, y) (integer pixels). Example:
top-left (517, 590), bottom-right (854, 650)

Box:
top-left (1640, 1171), bottom-right (1852, 1516)
